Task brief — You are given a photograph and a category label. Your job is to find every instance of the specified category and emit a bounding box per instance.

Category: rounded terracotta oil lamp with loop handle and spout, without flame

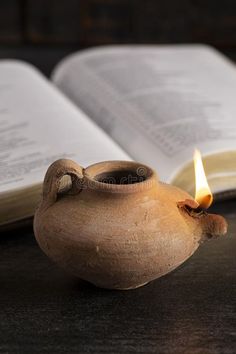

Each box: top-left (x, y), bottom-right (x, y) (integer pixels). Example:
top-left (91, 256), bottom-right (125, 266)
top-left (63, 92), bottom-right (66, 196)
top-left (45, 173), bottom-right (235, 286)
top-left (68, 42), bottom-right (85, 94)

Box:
top-left (34, 160), bottom-right (227, 289)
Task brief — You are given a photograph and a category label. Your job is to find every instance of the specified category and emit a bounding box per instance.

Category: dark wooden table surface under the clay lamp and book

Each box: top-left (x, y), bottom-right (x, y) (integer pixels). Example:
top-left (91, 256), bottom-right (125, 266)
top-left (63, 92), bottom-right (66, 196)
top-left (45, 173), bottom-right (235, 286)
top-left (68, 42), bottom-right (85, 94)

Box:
top-left (0, 48), bottom-right (236, 354)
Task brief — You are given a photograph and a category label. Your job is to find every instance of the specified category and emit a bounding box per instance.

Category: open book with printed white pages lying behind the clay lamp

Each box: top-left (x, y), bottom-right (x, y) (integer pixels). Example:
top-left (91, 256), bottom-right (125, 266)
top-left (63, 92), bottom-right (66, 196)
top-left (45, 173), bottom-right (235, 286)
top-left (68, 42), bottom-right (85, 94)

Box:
top-left (0, 45), bottom-right (236, 225)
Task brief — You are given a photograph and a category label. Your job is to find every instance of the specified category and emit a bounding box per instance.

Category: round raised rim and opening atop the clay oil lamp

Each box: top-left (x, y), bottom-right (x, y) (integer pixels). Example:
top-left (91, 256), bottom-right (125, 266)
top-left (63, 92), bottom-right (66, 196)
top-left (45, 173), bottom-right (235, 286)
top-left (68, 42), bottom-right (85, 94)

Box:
top-left (84, 160), bottom-right (158, 193)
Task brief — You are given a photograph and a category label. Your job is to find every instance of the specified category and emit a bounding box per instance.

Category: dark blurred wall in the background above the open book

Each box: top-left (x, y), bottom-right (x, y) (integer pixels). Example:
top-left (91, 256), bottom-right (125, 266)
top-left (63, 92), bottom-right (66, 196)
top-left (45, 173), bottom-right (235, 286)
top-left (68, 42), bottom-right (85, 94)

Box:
top-left (0, 0), bottom-right (236, 70)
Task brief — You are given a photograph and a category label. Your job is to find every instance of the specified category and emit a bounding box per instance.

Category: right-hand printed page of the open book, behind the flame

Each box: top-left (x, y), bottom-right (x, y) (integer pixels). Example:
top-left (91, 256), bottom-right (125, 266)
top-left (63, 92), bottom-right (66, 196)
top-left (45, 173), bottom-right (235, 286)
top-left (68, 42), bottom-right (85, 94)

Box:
top-left (53, 45), bottom-right (236, 181)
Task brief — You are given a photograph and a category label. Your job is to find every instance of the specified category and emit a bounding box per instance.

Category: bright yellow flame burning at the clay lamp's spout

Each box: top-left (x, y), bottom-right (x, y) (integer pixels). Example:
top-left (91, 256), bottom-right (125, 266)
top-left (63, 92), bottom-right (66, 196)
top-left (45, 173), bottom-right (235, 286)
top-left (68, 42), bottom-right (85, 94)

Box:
top-left (193, 149), bottom-right (213, 209)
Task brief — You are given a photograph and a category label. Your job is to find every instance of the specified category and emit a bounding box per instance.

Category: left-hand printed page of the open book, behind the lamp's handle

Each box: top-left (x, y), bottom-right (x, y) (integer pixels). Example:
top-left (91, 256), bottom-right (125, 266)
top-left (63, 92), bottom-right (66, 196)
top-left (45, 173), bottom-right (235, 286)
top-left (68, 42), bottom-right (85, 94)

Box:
top-left (0, 60), bottom-right (130, 195)
